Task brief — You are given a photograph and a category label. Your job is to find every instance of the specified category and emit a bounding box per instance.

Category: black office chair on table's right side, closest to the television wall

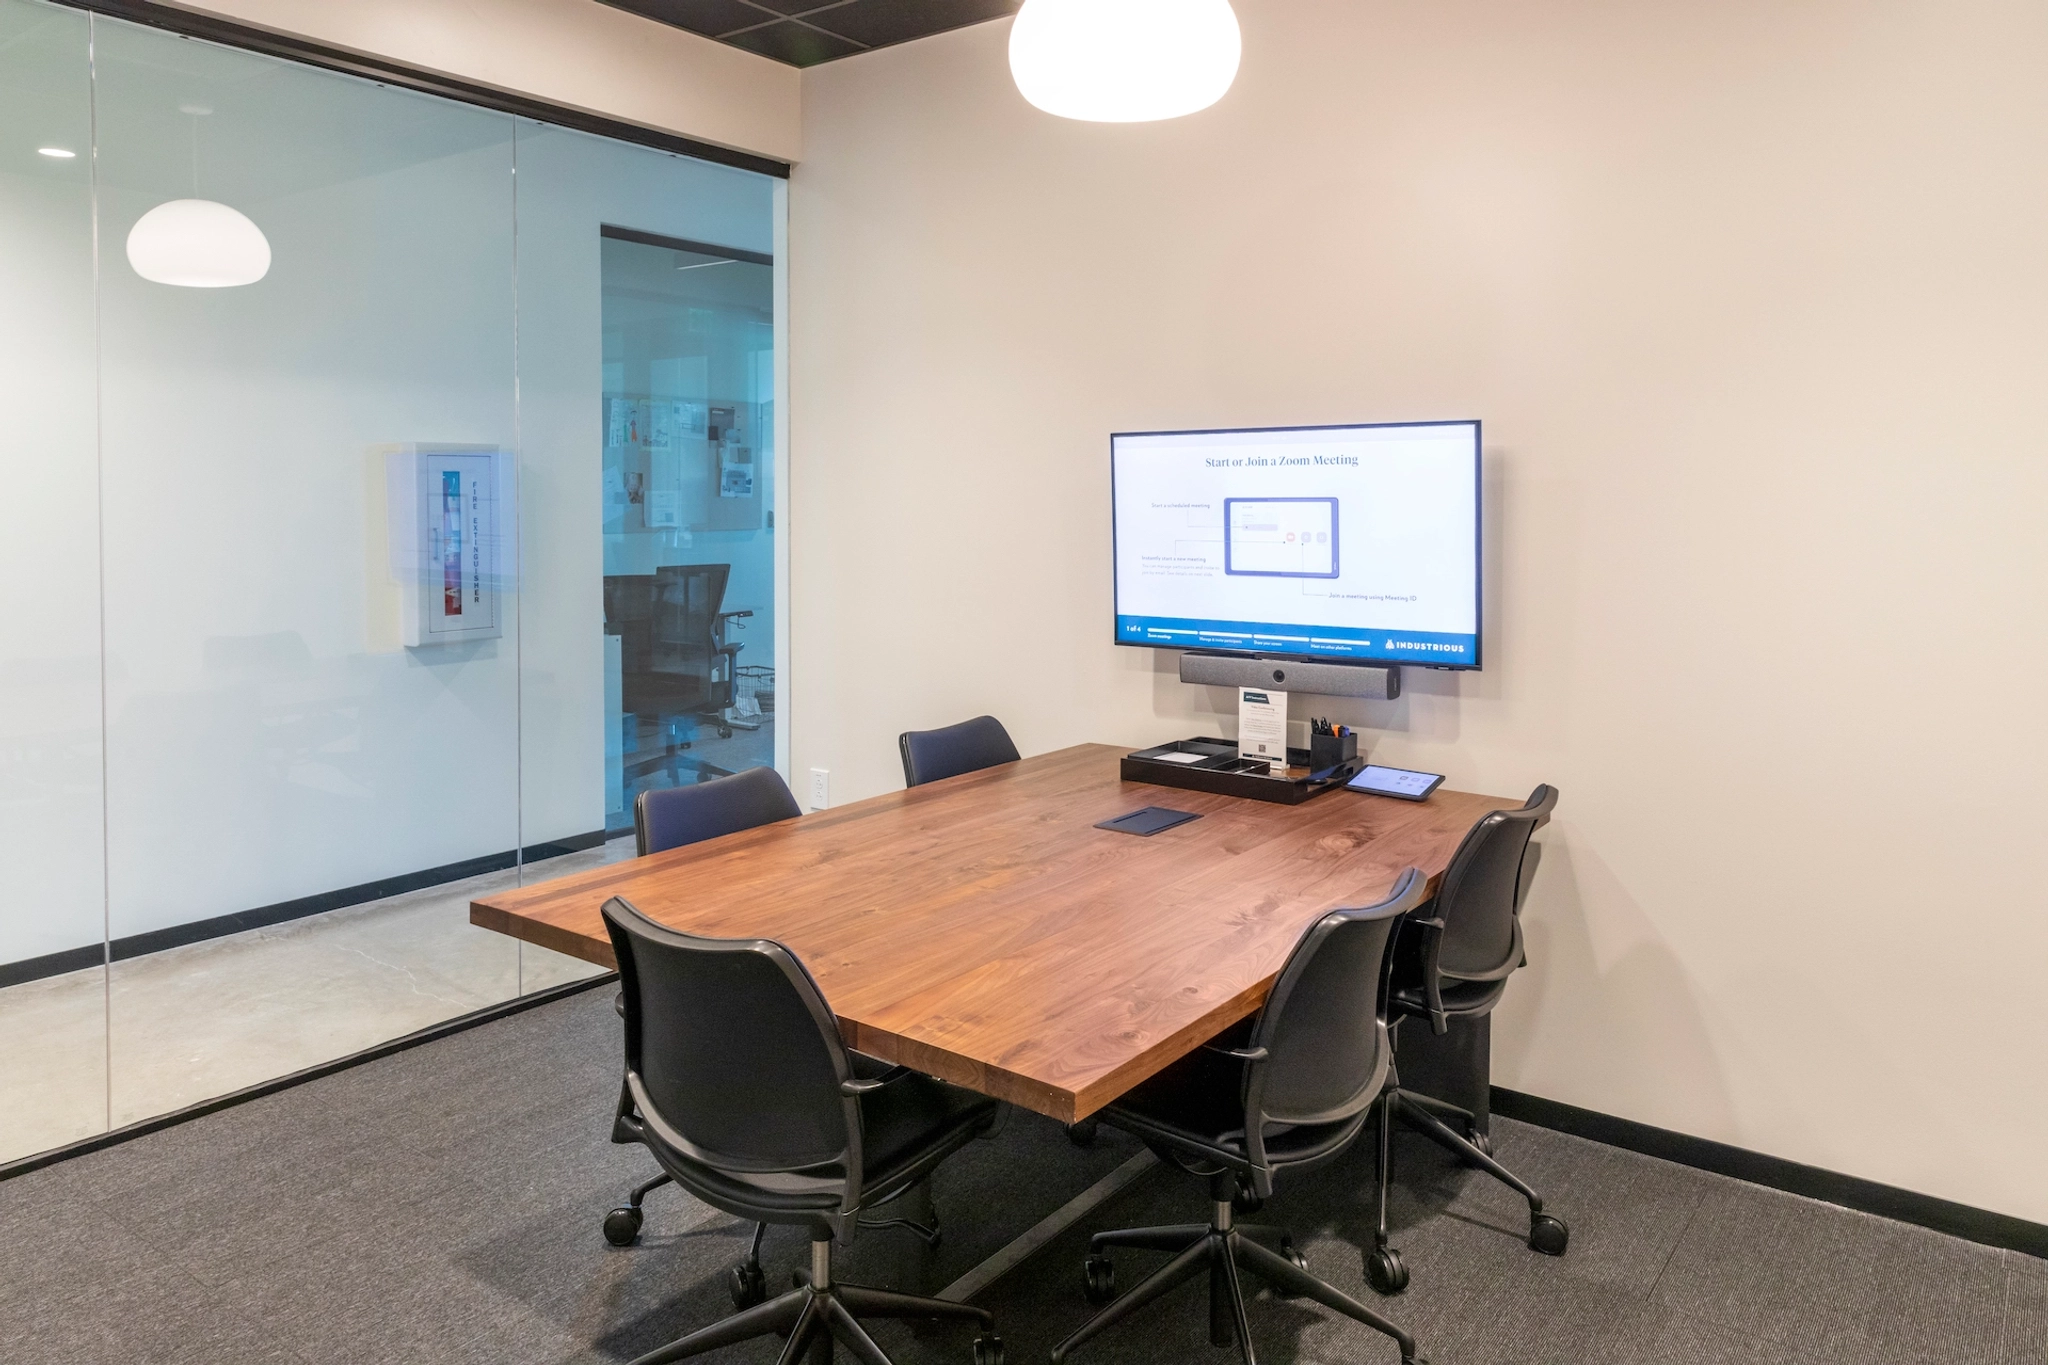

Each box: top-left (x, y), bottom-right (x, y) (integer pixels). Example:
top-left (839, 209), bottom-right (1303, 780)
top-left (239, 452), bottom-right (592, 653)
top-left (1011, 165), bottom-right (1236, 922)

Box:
top-left (1366, 786), bottom-right (1571, 1293)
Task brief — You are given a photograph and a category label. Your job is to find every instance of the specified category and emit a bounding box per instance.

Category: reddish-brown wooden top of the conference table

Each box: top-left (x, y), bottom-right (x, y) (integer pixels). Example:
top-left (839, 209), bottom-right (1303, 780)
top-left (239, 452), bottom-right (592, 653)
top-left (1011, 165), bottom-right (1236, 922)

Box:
top-left (469, 745), bottom-right (1522, 1121)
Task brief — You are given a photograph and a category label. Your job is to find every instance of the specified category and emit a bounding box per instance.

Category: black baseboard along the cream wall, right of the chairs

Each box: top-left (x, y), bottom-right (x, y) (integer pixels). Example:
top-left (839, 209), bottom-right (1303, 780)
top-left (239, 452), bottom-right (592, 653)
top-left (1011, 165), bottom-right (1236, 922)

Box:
top-left (1491, 1085), bottom-right (2048, 1259)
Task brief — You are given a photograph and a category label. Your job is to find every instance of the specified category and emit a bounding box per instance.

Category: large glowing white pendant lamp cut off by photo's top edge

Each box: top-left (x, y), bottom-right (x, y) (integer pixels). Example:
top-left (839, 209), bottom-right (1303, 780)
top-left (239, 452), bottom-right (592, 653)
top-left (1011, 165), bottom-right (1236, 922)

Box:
top-left (1010, 0), bottom-right (1243, 123)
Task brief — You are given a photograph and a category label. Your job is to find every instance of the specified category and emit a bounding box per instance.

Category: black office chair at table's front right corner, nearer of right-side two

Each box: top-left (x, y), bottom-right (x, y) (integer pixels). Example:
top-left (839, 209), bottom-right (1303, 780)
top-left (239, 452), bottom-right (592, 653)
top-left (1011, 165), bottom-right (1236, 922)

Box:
top-left (1053, 868), bottom-right (1427, 1365)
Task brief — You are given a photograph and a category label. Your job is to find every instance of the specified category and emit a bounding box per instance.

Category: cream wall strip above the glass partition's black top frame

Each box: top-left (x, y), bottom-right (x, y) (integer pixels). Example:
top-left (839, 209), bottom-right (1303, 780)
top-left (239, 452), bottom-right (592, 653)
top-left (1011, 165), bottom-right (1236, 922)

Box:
top-left (157, 0), bottom-right (801, 162)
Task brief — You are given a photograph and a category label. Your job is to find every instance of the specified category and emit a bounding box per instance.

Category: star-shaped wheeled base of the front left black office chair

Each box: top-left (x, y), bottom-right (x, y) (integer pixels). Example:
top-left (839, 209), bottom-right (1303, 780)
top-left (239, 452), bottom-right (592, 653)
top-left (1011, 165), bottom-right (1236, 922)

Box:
top-left (633, 1242), bottom-right (1004, 1365)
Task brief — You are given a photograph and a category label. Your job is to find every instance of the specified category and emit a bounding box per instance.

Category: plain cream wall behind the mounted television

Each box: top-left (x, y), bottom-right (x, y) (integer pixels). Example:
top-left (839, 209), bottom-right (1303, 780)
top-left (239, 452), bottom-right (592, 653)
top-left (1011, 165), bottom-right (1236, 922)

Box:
top-left (791, 0), bottom-right (2048, 1220)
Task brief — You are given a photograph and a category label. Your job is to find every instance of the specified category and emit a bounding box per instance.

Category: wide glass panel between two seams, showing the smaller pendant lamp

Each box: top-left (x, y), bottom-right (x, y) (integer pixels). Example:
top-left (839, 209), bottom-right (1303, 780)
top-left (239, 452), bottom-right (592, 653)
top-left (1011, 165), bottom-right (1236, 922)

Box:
top-left (96, 23), bottom-right (520, 1124)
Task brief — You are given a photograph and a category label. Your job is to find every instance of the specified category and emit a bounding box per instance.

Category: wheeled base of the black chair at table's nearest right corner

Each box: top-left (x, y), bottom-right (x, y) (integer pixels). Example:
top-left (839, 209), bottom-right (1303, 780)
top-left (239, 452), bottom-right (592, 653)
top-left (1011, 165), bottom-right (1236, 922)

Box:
top-left (1053, 1199), bottom-right (1425, 1365)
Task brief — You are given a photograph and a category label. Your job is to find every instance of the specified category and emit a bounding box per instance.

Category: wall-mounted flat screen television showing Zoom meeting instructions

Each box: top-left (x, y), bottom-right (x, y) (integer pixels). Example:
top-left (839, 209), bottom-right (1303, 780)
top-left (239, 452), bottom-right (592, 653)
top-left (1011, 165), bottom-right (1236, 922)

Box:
top-left (1110, 422), bottom-right (1479, 669)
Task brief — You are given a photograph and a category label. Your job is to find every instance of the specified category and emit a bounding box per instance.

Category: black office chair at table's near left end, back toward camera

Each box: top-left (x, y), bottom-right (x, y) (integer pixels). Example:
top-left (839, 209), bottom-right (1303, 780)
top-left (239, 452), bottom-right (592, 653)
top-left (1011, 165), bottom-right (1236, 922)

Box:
top-left (604, 896), bottom-right (1001, 1365)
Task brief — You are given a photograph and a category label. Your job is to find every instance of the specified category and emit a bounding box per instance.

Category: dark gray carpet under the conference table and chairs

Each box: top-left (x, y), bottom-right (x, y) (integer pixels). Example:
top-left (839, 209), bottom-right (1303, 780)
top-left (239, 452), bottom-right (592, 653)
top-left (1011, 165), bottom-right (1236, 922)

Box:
top-left (0, 990), bottom-right (2048, 1365)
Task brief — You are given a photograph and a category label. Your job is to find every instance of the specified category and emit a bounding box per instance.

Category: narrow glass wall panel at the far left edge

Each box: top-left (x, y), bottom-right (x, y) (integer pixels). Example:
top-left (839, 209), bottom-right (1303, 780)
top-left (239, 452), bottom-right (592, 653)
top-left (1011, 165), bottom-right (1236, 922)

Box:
top-left (0, 2), bottom-right (106, 1160)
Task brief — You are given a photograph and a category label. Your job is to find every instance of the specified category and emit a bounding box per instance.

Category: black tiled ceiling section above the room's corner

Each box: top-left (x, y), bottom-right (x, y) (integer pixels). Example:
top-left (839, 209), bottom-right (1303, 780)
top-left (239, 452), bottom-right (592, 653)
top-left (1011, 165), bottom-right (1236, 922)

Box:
top-left (600, 0), bottom-right (1024, 65)
